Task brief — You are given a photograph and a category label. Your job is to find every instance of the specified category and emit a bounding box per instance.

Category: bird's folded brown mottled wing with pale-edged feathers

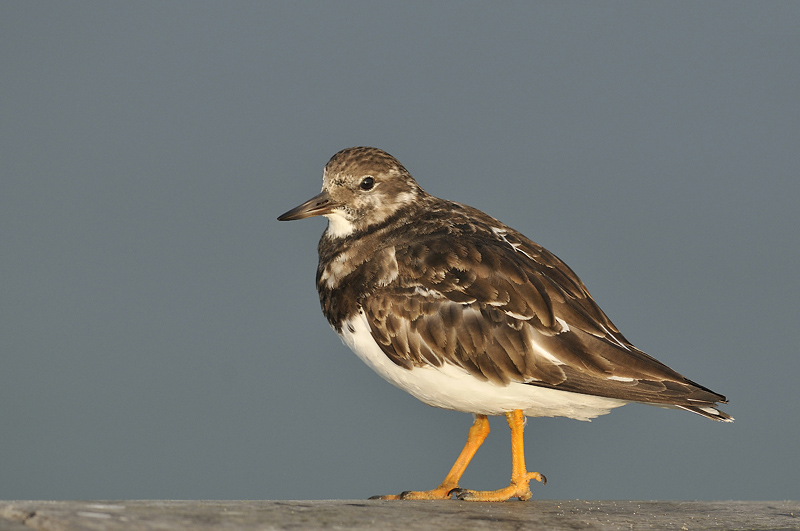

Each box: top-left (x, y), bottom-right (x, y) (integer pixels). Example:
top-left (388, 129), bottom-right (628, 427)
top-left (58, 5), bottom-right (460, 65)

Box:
top-left (364, 228), bottom-right (725, 416)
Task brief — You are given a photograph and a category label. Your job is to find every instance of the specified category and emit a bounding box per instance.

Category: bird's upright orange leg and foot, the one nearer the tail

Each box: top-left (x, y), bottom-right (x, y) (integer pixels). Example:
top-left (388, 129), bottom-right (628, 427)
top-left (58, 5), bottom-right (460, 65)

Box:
top-left (453, 409), bottom-right (547, 501)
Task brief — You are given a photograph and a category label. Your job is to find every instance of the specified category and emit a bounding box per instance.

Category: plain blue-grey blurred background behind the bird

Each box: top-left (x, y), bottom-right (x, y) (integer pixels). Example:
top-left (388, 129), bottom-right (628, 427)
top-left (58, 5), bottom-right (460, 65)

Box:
top-left (0, 1), bottom-right (800, 500)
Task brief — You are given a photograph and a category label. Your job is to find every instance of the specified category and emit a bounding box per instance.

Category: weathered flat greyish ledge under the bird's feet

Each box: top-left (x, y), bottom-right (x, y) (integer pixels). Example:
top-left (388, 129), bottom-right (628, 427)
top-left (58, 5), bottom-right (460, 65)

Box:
top-left (0, 500), bottom-right (800, 531)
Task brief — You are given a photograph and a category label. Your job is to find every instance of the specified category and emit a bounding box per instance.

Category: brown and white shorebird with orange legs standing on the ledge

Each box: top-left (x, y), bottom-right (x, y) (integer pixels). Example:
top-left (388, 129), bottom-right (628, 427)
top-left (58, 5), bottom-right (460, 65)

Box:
top-left (278, 147), bottom-right (733, 501)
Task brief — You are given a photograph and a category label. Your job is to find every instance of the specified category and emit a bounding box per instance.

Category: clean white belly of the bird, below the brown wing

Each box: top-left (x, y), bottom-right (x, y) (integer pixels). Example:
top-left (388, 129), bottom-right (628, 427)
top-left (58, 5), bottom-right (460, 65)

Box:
top-left (341, 313), bottom-right (627, 420)
